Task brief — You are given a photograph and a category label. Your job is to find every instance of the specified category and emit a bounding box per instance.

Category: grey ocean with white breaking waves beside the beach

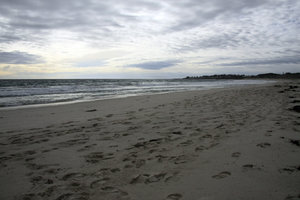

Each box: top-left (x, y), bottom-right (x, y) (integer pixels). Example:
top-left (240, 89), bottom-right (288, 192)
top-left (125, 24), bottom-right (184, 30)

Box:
top-left (0, 79), bottom-right (268, 108)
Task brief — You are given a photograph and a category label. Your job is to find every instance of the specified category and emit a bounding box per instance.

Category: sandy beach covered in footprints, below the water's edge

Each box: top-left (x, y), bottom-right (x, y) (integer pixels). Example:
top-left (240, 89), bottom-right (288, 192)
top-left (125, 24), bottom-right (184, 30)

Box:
top-left (0, 81), bottom-right (300, 200)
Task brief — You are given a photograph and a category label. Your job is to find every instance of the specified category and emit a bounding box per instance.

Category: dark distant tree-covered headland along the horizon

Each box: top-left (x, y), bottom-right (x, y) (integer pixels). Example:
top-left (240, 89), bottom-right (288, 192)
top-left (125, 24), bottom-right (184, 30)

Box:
top-left (185, 72), bottom-right (300, 79)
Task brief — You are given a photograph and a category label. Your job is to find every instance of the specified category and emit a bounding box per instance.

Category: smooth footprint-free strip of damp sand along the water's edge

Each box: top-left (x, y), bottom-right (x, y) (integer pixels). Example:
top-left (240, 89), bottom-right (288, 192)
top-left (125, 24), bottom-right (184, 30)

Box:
top-left (0, 82), bottom-right (276, 131)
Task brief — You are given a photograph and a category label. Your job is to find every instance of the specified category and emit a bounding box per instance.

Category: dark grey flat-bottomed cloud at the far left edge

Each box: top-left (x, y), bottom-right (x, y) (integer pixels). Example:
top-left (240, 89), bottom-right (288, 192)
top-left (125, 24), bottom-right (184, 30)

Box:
top-left (0, 51), bottom-right (43, 64)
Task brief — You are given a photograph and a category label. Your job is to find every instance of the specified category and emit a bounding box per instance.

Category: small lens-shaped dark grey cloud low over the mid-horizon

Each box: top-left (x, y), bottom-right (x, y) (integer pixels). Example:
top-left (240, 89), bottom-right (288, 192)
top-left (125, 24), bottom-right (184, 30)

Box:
top-left (129, 60), bottom-right (181, 70)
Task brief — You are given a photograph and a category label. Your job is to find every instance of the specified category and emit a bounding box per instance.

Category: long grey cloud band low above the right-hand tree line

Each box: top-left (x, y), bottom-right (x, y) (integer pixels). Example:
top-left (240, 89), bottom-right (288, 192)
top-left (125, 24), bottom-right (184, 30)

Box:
top-left (218, 56), bottom-right (300, 66)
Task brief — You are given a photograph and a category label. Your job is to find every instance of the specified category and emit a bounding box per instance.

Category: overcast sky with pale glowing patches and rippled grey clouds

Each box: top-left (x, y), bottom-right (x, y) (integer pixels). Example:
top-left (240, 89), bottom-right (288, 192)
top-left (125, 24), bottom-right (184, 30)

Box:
top-left (0, 0), bottom-right (300, 79)
